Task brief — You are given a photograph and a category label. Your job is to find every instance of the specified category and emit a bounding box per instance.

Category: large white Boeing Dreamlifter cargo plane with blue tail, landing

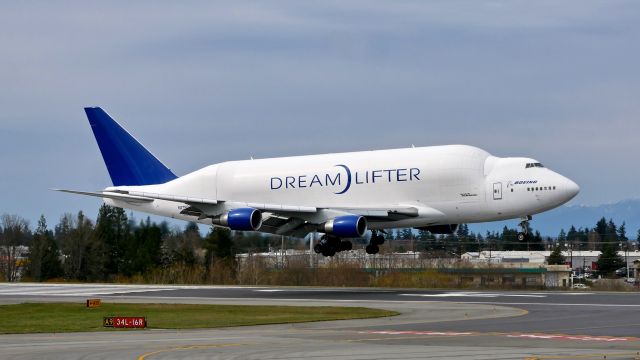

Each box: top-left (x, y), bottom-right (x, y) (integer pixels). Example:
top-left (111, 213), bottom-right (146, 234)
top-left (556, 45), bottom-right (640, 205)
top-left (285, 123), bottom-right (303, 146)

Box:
top-left (59, 107), bottom-right (579, 256)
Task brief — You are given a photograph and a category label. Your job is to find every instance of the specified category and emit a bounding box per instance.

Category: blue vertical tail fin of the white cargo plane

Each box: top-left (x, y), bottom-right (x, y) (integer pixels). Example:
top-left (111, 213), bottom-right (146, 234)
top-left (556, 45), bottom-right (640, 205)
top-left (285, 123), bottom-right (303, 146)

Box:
top-left (84, 107), bottom-right (176, 186)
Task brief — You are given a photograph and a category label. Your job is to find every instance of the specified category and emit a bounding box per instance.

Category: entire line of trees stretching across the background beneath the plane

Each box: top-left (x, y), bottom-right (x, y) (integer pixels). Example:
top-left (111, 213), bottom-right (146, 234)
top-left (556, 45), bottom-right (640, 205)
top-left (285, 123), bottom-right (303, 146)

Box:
top-left (0, 205), bottom-right (640, 283)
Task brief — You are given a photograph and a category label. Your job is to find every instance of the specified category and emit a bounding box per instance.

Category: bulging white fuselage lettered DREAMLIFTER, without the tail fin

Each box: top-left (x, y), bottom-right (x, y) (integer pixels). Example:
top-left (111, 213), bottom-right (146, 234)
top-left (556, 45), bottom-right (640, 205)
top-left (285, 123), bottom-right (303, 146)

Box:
top-left (105, 145), bottom-right (579, 229)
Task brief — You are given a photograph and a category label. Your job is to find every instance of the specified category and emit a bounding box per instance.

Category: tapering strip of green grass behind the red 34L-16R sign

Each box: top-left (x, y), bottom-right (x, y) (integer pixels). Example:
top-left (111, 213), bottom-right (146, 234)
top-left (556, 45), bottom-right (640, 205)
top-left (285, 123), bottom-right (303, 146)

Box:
top-left (0, 303), bottom-right (398, 334)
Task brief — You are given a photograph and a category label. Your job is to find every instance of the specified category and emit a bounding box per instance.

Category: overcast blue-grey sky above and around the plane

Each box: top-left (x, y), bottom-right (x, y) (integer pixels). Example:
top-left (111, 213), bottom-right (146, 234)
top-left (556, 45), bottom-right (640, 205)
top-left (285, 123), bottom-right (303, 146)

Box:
top-left (0, 0), bottom-right (640, 225)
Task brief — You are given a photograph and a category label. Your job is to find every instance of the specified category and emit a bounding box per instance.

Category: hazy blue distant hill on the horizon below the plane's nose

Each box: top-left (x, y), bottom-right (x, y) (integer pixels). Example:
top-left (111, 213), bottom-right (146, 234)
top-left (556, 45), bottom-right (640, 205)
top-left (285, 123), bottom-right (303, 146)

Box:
top-left (469, 199), bottom-right (640, 239)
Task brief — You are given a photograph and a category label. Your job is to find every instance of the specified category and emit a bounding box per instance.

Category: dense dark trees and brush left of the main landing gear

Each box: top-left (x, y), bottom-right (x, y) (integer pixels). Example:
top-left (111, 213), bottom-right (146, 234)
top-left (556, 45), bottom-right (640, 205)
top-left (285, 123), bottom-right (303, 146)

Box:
top-left (0, 205), bottom-right (290, 281)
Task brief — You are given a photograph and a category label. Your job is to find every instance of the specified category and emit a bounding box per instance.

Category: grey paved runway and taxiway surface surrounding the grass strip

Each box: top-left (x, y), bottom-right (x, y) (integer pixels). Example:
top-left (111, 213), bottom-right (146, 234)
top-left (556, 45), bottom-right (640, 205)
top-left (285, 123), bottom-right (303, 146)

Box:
top-left (0, 284), bottom-right (640, 359)
